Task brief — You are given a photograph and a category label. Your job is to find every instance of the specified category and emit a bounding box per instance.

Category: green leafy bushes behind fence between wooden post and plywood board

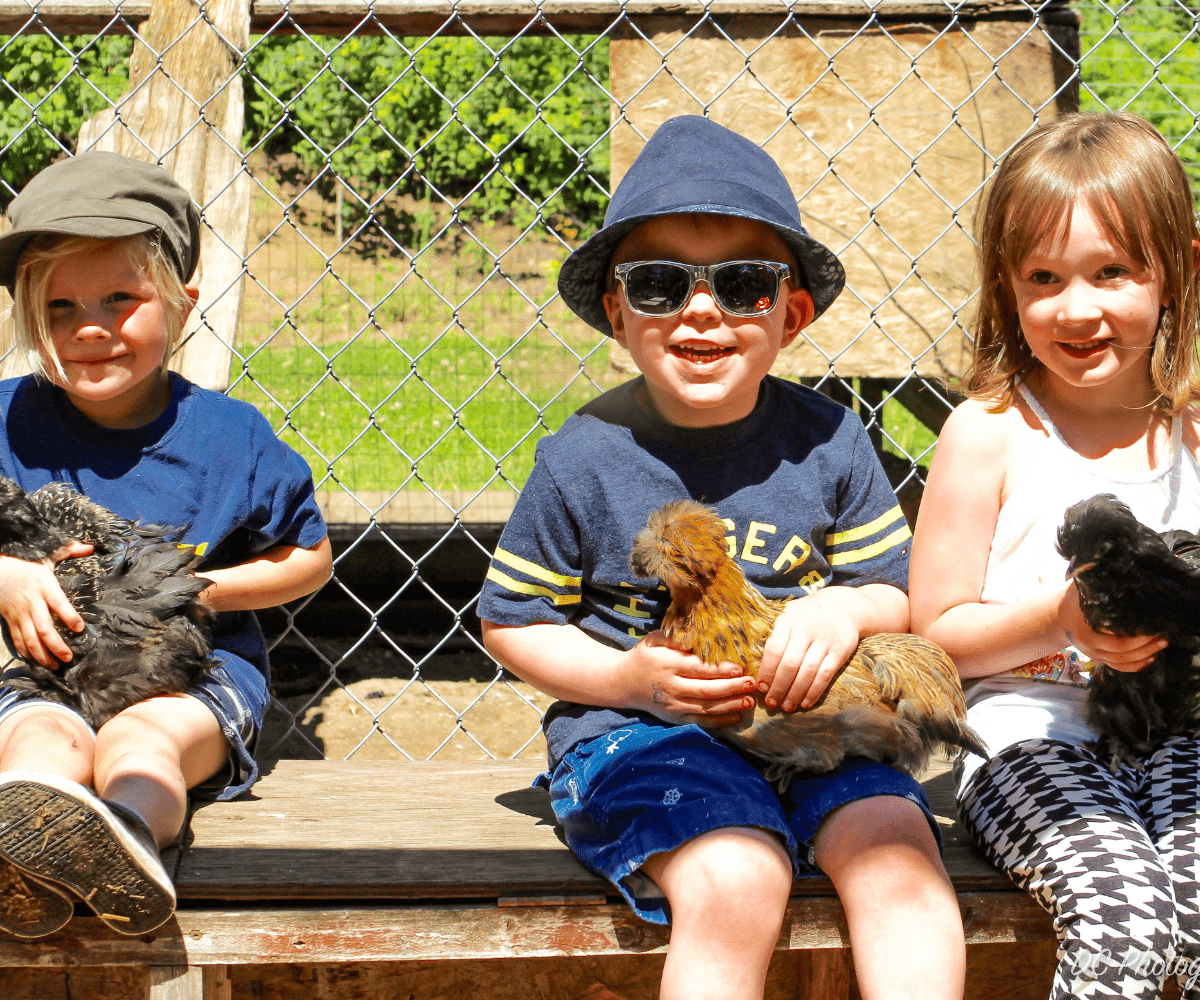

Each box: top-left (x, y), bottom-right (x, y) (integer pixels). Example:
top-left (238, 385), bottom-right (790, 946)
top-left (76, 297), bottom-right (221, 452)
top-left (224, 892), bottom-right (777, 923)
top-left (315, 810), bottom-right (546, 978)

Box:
top-left (246, 36), bottom-right (608, 238)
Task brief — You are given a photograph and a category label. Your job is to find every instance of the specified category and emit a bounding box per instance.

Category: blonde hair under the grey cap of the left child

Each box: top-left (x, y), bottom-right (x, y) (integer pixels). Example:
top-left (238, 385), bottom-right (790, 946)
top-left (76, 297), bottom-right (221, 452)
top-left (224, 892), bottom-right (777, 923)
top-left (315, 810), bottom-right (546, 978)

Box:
top-left (12, 233), bottom-right (193, 379)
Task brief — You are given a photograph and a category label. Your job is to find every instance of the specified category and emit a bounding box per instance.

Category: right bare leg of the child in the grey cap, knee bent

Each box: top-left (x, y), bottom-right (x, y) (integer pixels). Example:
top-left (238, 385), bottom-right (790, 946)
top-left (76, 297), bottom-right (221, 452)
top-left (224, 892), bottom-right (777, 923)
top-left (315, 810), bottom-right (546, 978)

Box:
top-left (95, 695), bottom-right (229, 848)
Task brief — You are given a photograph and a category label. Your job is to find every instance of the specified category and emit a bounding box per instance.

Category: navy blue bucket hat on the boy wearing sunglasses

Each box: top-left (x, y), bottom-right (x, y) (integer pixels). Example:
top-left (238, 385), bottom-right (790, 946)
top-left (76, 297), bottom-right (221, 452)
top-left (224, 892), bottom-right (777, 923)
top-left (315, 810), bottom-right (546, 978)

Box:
top-left (558, 114), bottom-right (846, 336)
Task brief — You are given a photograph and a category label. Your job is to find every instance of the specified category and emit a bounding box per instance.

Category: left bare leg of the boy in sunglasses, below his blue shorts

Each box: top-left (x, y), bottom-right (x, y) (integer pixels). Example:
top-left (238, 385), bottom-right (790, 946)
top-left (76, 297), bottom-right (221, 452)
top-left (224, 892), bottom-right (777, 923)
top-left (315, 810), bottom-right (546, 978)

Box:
top-left (642, 827), bottom-right (792, 1000)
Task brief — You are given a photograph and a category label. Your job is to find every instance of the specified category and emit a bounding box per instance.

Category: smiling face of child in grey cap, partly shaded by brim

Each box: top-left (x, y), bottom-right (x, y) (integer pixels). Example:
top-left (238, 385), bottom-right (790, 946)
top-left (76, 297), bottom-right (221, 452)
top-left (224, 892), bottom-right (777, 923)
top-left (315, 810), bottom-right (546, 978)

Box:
top-left (46, 240), bottom-right (191, 427)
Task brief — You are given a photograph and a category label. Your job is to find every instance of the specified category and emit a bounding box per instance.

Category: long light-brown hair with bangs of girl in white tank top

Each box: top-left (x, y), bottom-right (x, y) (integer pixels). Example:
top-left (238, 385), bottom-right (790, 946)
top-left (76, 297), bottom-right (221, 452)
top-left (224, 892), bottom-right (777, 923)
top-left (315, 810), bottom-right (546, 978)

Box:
top-left (964, 112), bottom-right (1200, 413)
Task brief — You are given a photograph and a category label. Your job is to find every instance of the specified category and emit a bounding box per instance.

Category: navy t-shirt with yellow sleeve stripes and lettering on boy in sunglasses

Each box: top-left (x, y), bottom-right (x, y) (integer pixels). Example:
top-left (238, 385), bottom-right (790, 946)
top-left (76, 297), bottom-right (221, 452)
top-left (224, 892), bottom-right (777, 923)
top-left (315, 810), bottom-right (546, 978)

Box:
top-left (479, 377), bottom-right (912, 767)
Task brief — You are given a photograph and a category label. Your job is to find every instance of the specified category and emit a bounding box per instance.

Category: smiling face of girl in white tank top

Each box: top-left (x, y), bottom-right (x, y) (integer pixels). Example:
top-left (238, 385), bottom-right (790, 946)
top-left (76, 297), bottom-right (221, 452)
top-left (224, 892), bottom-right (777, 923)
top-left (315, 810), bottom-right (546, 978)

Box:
top-left (1012, 198), bottom-right (1169, 406)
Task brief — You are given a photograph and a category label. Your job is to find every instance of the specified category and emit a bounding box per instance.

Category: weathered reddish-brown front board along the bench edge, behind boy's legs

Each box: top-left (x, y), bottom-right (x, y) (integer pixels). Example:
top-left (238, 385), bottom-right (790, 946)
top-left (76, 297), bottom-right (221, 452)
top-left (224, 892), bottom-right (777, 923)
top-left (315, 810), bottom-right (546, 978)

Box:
top-left (0, 893), bottom-right (1054, 975)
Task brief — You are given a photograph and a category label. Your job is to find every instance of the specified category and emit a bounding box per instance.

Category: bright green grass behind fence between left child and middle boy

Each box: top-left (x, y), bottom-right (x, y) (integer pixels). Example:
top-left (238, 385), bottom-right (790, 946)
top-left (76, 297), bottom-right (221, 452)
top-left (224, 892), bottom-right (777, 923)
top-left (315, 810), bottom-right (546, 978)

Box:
top-left (232, 333), bottom-right (614, 490)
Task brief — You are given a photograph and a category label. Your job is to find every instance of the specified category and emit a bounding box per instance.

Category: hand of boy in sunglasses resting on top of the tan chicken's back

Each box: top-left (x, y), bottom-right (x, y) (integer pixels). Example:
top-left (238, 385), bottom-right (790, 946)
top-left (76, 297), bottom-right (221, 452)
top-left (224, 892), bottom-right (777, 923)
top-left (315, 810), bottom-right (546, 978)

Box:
top-left (758, 592), bottom-right (859, 712)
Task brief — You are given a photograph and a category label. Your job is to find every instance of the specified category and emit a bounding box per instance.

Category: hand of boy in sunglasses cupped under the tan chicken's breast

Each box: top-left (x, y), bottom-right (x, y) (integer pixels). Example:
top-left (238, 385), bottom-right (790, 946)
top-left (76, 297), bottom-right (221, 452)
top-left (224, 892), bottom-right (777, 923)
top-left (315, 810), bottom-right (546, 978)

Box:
top-left (626, 631), bottom-right (754, 729)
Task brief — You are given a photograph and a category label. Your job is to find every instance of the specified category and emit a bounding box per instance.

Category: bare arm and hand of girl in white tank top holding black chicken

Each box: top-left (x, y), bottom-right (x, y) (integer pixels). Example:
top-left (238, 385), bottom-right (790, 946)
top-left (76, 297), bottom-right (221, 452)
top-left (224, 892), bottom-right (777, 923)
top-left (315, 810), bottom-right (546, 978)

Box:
top-left (908, 400), bottom-right (1162, 677)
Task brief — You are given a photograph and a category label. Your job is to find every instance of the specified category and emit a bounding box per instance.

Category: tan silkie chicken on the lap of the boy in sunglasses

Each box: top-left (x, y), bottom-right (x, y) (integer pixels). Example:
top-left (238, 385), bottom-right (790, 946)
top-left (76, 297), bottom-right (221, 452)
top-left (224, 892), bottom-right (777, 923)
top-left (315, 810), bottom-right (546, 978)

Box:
top-left (629, 501), bottom-right (988, 791)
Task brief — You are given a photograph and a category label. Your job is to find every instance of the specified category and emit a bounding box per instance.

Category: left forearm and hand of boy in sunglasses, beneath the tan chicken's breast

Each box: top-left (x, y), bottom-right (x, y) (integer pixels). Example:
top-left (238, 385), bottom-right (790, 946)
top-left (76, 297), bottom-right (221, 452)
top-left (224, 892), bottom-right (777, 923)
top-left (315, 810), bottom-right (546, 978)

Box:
top-left (484, 621), bottom-right (754, 726)
